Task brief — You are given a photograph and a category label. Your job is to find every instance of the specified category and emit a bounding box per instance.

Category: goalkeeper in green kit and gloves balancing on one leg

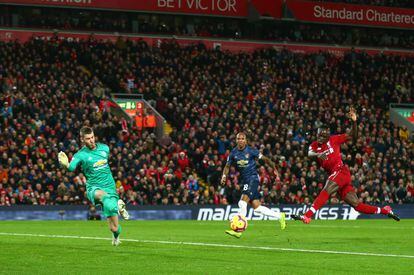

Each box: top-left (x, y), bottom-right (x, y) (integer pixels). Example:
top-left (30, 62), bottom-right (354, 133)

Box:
top-left (58, 126), bottom-right (129, 246)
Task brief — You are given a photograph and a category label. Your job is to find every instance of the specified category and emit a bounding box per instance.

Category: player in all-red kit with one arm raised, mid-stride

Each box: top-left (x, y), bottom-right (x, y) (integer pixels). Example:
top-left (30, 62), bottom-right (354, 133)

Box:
top-left (292, 108), bottom-right (400, 223)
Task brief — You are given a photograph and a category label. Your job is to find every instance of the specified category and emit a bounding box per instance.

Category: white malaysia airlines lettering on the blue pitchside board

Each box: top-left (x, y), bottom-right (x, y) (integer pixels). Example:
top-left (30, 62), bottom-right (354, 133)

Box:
top-left (197, 205), bottom-right (359, 221)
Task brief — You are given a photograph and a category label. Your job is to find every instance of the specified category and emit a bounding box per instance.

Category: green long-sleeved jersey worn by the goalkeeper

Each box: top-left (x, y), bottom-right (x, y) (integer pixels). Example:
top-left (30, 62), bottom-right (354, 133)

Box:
top-left (68, 143), bottom-right (115, 189)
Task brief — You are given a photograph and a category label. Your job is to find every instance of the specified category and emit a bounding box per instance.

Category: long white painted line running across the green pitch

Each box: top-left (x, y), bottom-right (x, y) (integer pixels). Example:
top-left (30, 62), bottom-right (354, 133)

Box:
top-left (0, 232), bottom-right (414, 259)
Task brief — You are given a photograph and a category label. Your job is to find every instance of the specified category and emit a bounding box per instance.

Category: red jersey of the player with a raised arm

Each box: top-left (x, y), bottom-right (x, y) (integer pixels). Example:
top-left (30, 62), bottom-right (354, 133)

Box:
top-left (309, 134), bottom-right (348, 174)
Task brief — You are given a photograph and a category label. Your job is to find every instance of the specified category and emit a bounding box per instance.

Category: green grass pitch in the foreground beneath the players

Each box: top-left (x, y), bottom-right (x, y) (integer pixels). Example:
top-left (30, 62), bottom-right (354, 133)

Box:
top-left (0, 220), bottom-right (414, 274)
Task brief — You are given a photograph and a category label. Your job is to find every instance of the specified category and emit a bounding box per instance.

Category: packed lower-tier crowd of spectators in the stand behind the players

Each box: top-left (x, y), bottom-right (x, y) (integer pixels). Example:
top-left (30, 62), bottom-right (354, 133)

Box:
top-left (0, 38), bottom-right (414, 208)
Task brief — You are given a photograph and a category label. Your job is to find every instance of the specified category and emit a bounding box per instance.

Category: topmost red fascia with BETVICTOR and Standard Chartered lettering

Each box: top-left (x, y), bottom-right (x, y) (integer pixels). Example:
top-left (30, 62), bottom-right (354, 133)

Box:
top-left (0, 0), bottom-right (414, 29)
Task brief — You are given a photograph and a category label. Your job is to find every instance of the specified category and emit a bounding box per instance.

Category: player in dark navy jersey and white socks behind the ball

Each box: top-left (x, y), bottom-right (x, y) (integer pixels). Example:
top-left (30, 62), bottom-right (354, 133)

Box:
top-left (221, 132), bottom-right (286, 238)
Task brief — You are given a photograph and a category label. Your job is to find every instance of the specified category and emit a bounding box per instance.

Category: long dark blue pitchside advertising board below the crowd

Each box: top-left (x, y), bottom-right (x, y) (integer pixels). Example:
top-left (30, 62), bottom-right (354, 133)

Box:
top-left (0, 204), bottom-right (414, 221)
